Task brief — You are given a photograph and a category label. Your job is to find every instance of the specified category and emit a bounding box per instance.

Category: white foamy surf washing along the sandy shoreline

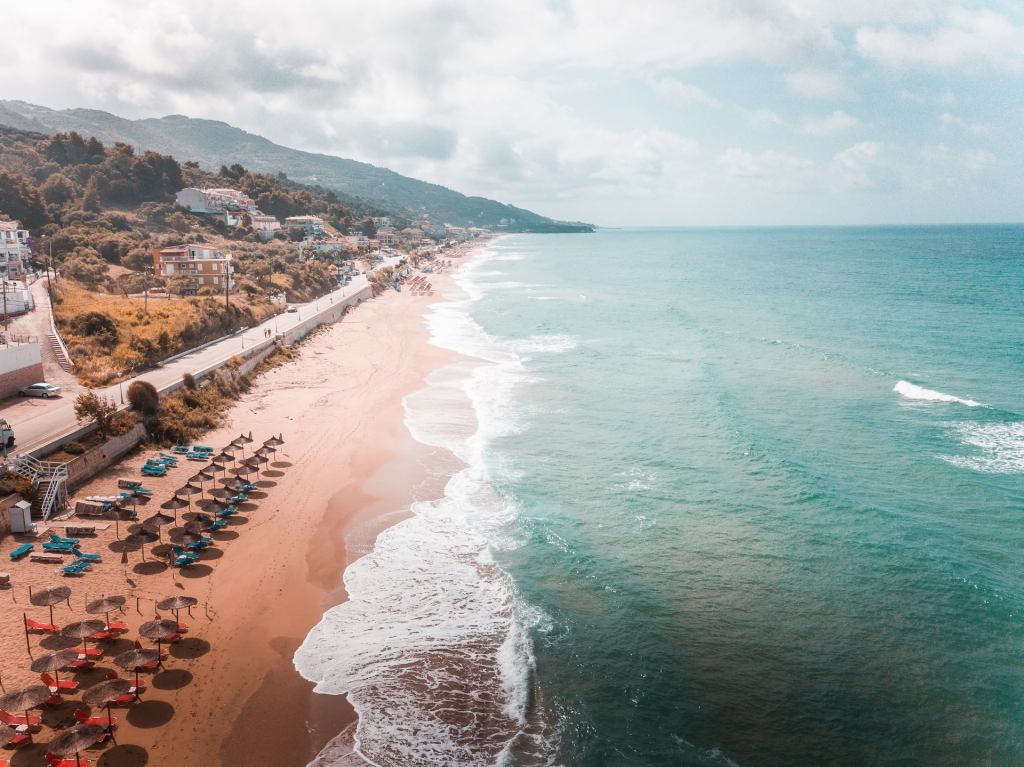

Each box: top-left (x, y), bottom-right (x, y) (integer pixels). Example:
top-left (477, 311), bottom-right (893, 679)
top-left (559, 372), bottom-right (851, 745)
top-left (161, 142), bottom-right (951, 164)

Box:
top-left (295, 242), bottom-right (557, 767)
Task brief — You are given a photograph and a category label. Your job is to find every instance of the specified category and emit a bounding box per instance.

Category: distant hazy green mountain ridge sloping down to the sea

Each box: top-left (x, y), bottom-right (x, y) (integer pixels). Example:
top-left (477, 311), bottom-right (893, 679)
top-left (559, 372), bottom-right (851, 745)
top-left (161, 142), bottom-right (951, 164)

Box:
top-left (0, 101), bottom-right (591, 232)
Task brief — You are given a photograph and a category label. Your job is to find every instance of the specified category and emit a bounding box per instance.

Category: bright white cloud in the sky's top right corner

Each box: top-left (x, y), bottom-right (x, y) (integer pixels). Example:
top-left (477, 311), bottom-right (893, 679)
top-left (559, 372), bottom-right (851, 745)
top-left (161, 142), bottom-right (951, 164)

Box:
top-left (856, 8), bottom-right (1024, 70)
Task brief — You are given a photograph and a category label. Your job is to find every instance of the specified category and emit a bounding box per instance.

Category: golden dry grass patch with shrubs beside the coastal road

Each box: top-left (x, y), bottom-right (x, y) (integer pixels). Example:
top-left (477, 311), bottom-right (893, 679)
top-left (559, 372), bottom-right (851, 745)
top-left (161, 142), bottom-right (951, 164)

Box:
top-left (53, 280), bottom-right (273, 386)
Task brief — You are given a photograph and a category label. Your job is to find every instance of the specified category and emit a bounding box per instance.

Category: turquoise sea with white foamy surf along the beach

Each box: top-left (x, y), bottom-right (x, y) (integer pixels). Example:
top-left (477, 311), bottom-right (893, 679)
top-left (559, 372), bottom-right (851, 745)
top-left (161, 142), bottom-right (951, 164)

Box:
top-left (295, 225), bottom-right (1024, 767)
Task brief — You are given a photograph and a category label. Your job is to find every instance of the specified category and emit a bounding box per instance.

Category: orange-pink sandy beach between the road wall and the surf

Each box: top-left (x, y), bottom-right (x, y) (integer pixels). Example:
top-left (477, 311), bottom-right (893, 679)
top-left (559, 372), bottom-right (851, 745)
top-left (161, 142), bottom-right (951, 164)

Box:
top-left (0, 245), bottom-right (479, 767)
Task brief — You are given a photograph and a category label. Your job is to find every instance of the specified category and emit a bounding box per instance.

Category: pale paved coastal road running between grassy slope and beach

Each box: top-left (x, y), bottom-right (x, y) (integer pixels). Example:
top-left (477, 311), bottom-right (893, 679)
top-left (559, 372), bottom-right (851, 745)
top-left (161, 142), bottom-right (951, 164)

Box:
top-left (6, 272), bottom-right (374, 453)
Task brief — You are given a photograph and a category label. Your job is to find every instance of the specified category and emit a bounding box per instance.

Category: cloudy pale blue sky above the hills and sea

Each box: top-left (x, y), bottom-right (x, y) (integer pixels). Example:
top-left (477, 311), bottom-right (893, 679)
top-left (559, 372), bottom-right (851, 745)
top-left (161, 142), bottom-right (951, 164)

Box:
top-left (0, 0), bottom-right (1024, 226)
